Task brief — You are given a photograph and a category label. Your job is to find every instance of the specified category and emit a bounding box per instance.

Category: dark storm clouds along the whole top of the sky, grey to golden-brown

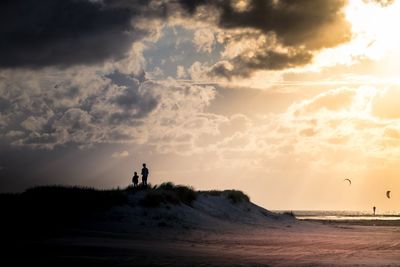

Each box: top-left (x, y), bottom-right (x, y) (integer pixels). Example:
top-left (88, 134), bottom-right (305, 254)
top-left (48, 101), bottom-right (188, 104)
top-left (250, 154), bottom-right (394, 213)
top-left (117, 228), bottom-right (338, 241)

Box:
top-left (0, 0), bottom-right (350, 71)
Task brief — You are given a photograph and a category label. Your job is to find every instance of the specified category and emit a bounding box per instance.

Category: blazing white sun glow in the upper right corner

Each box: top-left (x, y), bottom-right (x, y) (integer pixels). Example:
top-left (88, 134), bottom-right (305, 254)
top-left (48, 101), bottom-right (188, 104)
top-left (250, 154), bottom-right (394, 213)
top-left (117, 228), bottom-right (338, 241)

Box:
top-left (302, 0), bottom-right (400, 85)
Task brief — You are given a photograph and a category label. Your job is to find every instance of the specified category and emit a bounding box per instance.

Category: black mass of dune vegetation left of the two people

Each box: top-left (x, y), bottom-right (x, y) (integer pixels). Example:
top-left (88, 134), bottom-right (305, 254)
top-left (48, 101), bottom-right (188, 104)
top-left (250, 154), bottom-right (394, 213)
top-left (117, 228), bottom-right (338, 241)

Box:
top-left (0, 186), bottom-right (128, 241)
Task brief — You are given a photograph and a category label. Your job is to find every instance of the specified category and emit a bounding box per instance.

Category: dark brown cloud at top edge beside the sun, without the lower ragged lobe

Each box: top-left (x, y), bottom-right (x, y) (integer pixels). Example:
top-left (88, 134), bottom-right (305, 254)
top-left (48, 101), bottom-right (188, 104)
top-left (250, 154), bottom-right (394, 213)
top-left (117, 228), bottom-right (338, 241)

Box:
top-left (180, 0), bottom-right (350, 49)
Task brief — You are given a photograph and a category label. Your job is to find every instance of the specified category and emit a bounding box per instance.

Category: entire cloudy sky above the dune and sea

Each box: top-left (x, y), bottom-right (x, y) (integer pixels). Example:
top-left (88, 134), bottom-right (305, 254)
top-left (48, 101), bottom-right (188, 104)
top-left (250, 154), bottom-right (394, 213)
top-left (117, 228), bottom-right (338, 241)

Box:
top-left (0, 0), bottom-right (400, 212)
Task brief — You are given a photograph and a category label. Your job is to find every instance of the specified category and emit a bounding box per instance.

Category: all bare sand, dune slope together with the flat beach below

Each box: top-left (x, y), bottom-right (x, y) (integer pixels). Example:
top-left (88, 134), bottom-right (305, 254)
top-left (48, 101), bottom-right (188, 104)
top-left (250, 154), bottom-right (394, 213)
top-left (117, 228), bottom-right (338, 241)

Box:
top-left (7, 193), bottom-right (400, 266)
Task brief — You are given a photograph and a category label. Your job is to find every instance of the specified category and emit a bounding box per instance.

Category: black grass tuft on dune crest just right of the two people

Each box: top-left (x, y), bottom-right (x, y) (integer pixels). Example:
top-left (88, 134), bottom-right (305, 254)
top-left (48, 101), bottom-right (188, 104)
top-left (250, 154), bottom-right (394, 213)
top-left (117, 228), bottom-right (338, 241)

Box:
top-left (141, 182), bottom-right (197, 207)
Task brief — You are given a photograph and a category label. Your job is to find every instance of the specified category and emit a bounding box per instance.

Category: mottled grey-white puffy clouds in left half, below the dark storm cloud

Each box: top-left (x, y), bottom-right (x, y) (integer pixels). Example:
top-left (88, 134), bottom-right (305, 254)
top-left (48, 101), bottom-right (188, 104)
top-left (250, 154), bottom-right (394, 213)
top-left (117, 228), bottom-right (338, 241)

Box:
top-left (0, 65), bottom-right (222, 153)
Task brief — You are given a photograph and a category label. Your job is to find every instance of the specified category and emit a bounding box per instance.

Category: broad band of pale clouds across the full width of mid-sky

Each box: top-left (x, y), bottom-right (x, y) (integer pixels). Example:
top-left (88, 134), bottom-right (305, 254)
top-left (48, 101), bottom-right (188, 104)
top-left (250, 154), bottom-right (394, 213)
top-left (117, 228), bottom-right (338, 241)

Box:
top-left (0, 60), bottom-right (400, 177)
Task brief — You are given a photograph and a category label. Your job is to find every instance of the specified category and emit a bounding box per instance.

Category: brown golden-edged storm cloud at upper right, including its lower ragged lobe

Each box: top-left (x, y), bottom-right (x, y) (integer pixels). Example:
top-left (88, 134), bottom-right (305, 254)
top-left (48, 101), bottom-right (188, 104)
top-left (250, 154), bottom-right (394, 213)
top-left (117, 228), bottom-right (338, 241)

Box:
top-left (180, 0), bottom-right (351, 79)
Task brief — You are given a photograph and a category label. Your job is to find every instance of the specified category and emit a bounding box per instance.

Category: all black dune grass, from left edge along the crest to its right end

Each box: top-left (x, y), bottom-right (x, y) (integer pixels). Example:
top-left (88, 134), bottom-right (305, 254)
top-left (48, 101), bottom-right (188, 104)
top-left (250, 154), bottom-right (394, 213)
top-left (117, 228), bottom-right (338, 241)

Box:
top-left (0, 182), bottom-right (249, 236)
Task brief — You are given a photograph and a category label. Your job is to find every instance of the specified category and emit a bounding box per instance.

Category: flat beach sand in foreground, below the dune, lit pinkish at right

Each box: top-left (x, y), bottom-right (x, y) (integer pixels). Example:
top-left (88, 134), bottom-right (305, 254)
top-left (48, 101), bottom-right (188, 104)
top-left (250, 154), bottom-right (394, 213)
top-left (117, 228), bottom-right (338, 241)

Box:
top-left (10, 222), bottom-right (400, 266)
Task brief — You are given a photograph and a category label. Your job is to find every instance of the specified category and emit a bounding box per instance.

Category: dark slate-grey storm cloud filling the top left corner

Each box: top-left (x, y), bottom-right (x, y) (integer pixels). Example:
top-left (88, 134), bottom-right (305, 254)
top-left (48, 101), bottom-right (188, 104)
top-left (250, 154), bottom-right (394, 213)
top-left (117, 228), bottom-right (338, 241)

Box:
top-left (0, 0), bottom-right (161, 68)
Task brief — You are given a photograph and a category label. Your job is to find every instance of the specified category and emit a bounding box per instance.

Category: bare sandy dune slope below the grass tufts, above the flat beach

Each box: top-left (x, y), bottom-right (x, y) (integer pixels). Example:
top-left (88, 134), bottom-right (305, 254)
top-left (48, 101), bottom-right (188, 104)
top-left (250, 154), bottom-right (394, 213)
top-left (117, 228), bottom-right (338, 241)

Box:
top-left (97, 192), bottom-right (298, 233)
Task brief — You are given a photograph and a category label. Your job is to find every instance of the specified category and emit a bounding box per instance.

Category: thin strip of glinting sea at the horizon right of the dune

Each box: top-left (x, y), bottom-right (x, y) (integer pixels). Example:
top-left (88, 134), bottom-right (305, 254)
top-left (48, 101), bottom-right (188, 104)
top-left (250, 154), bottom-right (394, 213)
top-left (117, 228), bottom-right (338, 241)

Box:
top-left (275, 210), bottom-right (400, 221)
